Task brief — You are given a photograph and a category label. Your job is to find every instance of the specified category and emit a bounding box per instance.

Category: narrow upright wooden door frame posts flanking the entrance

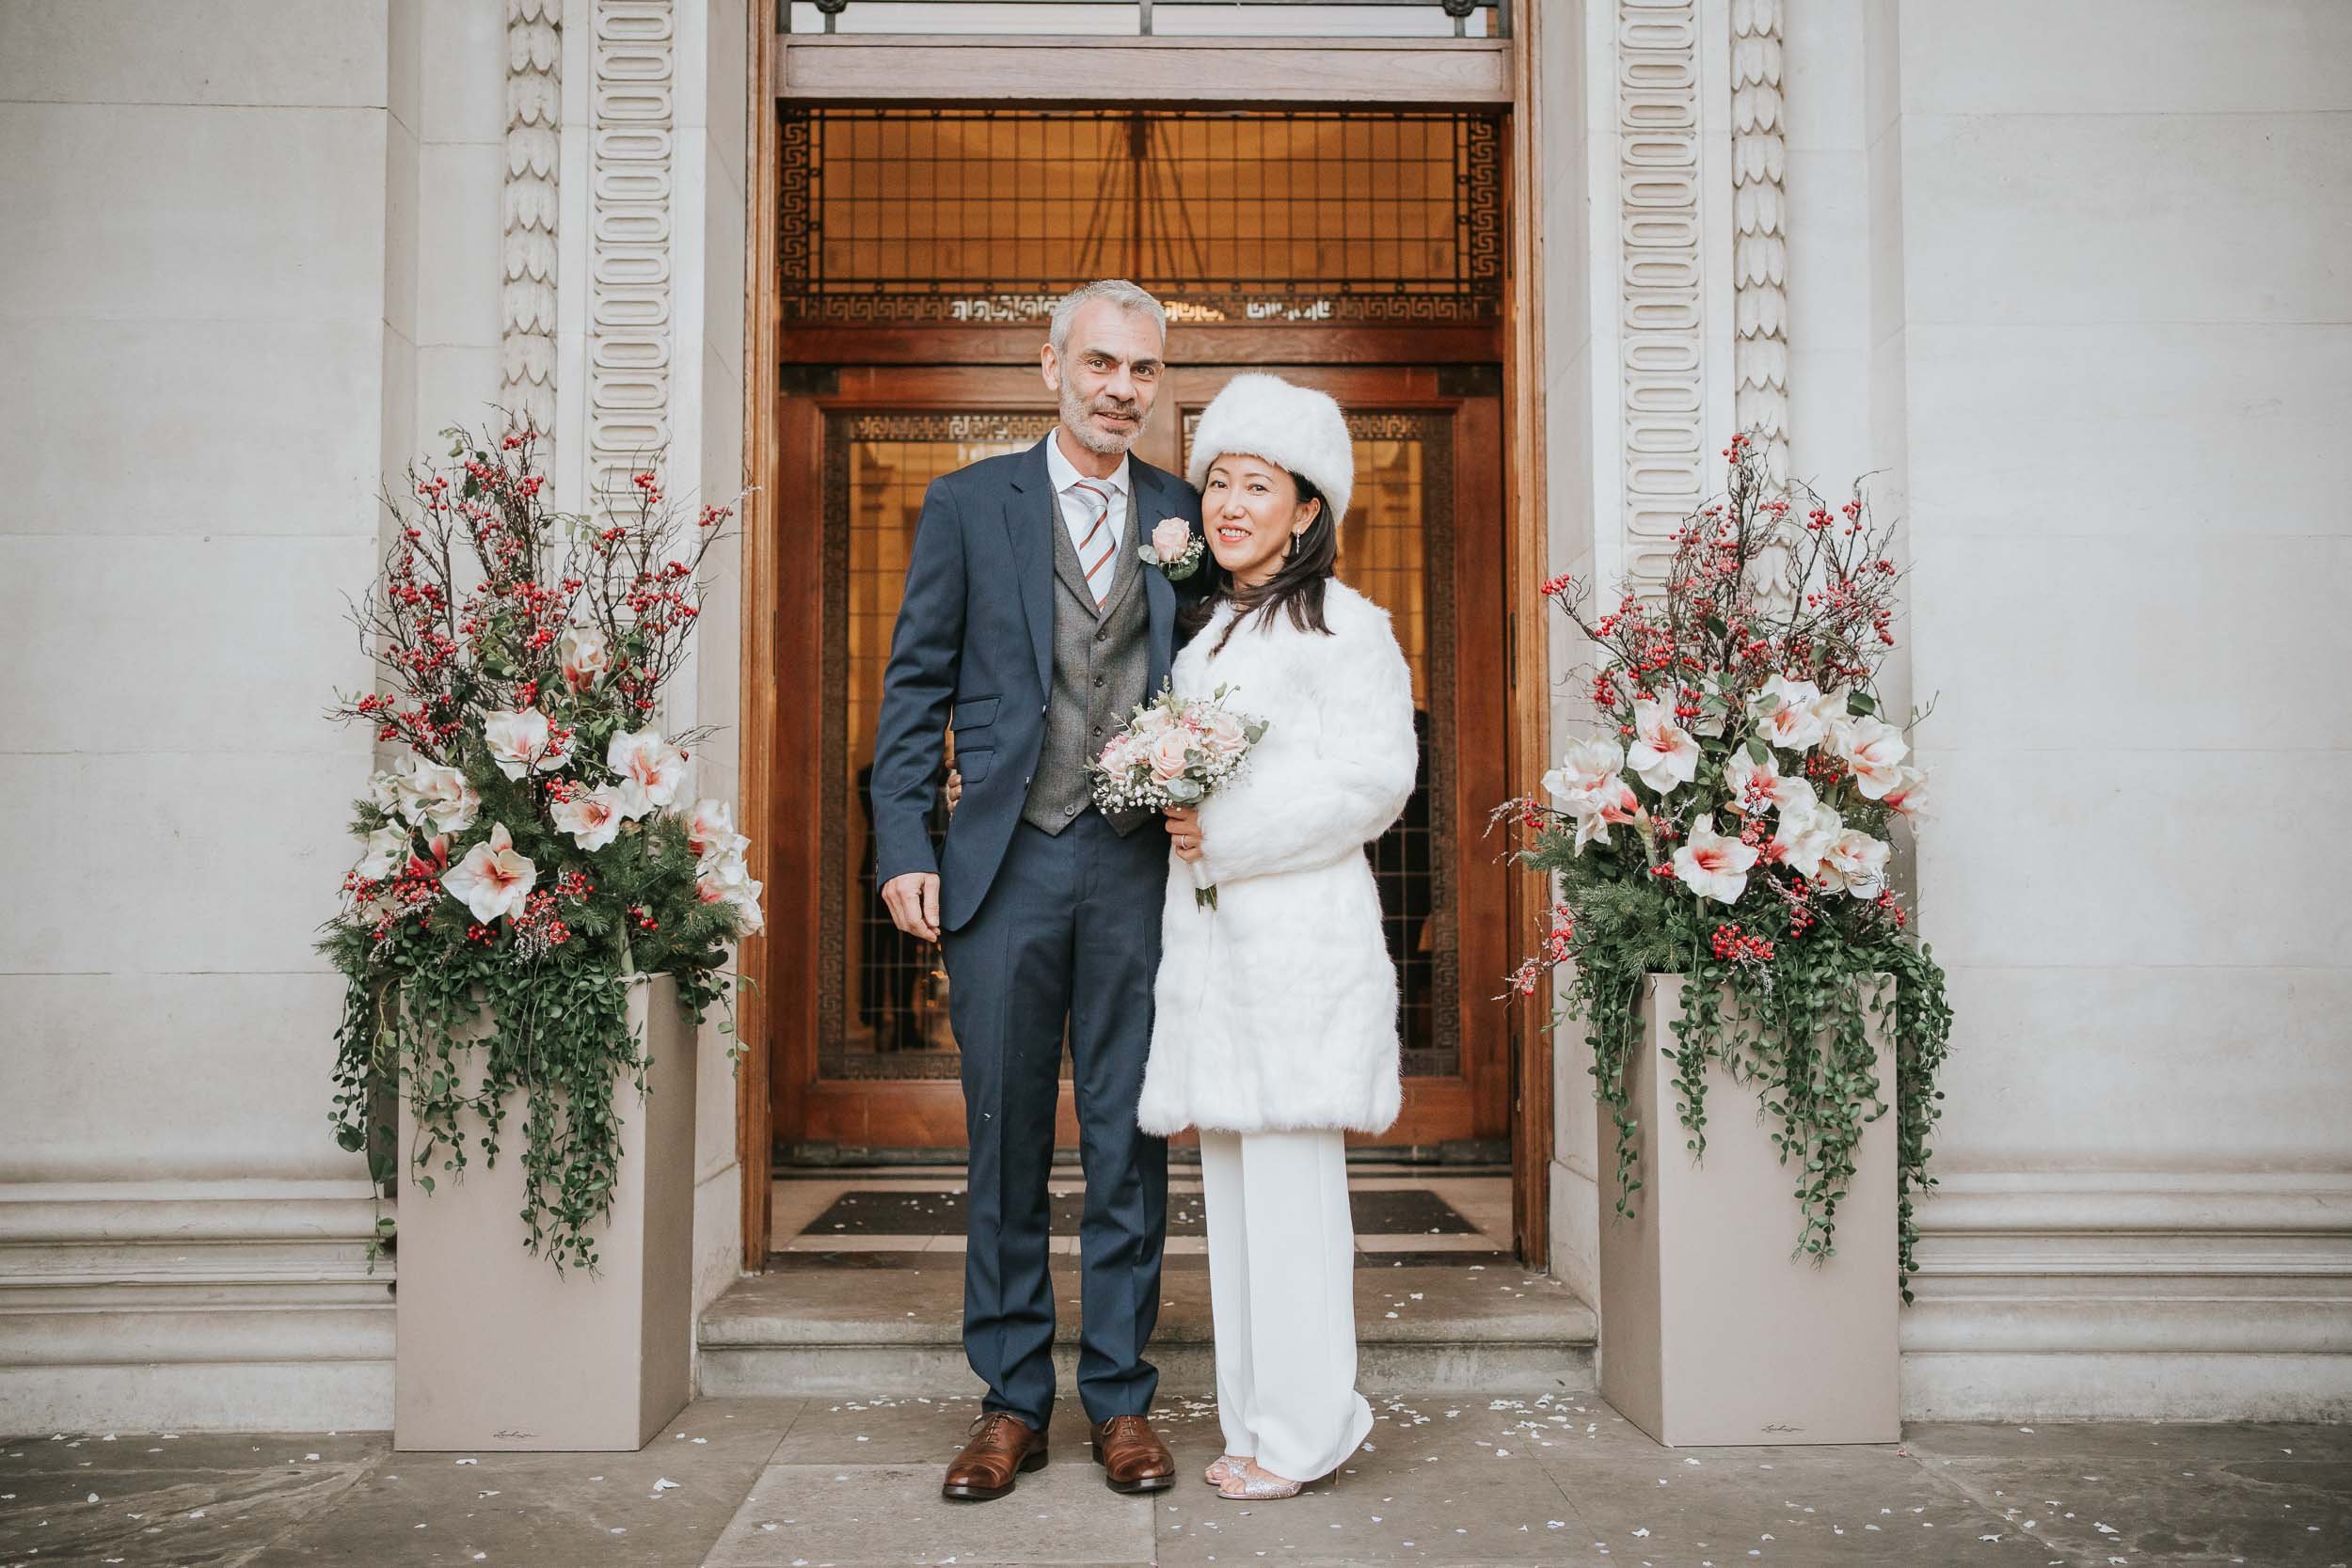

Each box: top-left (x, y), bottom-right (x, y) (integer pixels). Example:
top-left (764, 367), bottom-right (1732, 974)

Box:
top-left (737, 21), bottom-right (1552, 1272)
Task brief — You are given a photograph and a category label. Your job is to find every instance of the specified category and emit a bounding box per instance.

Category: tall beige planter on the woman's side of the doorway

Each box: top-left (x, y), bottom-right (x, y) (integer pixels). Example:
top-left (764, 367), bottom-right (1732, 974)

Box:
top-left (1597, 975), bottom-right (1903, 1449)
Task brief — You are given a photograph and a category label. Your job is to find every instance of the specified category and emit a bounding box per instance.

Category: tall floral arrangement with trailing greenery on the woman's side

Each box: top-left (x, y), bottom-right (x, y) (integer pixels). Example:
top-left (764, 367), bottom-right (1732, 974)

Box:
top-left (1496, 435), bottom-right (1952, 1300)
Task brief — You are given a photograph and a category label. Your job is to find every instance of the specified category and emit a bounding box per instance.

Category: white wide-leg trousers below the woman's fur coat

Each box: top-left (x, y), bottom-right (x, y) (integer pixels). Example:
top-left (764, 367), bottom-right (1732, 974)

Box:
top-left (1200, 1131), bottom-right (1372, 1481)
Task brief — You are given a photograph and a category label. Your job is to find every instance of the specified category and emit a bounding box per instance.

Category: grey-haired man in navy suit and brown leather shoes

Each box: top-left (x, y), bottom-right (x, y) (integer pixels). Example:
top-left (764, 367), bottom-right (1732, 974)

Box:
top-left (873, 282), bottom-right (1200, 1502)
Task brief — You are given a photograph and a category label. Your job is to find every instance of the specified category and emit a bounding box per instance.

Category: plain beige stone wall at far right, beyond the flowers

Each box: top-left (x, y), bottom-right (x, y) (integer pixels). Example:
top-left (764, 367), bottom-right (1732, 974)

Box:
top-left (1866, 0), bottom-right (2352, 1418)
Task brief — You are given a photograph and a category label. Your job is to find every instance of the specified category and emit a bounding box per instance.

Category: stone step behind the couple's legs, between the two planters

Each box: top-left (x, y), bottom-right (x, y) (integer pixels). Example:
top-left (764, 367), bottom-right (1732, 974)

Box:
top-left (699, 1253), bottom-right (1595, 1399)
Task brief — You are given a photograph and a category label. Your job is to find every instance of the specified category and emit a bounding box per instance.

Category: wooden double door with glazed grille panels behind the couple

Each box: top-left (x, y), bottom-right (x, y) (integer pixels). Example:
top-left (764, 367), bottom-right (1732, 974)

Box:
top-left (755, 367), bottom-right (1510, 1159)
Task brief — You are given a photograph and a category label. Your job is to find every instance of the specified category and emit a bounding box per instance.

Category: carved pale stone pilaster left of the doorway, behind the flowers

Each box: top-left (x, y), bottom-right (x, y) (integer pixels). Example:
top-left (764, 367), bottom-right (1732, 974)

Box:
top-left (555, 0), bottom-right (743, 1303)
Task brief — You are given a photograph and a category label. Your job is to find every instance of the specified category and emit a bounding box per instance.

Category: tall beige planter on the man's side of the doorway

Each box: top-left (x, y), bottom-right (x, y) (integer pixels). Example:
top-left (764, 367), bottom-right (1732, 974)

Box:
top-left (393, 975), bottom-right (694, 1450)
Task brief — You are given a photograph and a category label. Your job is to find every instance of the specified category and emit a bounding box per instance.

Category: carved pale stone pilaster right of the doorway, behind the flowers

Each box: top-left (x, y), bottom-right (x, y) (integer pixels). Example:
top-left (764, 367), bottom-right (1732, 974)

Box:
top-left (1538, 0), bottom-right (1753, 1300)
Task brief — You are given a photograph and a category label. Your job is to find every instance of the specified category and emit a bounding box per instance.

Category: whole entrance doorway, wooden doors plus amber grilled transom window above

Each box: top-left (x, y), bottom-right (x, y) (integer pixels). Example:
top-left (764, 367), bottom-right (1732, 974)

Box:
top-left (743, 86), bottom-right (1548, 1253)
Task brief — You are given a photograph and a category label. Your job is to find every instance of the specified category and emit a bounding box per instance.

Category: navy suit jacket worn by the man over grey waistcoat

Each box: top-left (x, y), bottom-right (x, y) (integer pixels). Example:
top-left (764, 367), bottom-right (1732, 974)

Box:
top-left (873, 435), bottom-right (1209, 931)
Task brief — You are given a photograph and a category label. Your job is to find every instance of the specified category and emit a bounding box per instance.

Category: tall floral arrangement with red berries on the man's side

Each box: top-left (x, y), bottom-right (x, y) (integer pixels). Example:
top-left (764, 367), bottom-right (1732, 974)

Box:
top-left (320, 430), bottom-right (760, 1270)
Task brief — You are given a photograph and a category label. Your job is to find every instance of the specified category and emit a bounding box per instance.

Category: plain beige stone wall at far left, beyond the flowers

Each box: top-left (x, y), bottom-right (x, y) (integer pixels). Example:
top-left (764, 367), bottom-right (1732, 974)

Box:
top-left (0, 0), bottom-right (417, 1430)
